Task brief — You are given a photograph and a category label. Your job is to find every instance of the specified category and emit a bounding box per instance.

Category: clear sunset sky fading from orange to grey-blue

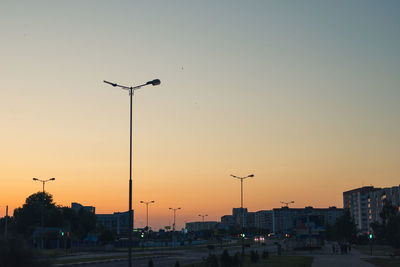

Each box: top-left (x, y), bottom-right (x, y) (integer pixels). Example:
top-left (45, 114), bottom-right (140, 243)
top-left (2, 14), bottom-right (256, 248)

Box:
top-left (0, 0), bottom-right (400, 229)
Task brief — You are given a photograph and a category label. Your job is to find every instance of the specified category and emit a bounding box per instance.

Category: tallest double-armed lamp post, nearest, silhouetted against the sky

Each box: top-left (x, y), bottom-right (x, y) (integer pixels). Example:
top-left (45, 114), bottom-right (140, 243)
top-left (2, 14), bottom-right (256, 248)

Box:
top-left (104, 79), bottom-right (161, 267)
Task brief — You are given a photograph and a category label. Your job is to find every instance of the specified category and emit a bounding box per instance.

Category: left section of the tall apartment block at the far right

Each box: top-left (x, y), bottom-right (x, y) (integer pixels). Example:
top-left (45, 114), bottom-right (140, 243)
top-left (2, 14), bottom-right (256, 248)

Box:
top-left (343, 186), bottom-right (381, 233)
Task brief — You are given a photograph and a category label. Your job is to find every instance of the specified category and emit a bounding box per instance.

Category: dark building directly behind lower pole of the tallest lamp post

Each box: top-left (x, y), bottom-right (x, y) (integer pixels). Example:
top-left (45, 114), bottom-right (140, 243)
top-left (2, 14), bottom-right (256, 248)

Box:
top-left (96, 211), bottom-right (134, 235)
